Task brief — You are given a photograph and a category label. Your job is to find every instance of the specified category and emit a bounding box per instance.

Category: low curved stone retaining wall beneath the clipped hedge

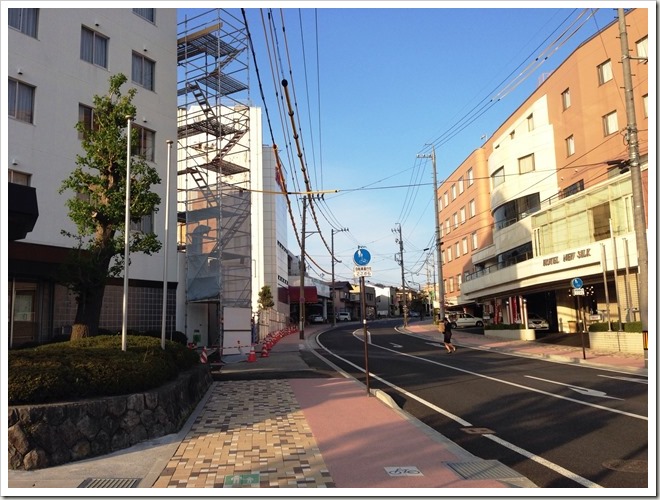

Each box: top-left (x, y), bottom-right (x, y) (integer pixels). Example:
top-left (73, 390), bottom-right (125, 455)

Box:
top-left (8, 365), bottom-right (212, 470)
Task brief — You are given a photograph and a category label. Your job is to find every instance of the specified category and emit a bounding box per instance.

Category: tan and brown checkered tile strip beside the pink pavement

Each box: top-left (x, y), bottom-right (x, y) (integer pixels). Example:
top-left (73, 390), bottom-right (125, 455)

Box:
top-left (153, 380), bottom-right (335, 488)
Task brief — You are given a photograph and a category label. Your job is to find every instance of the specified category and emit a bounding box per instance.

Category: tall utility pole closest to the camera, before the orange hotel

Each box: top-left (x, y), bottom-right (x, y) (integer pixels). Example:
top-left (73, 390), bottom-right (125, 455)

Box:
top-left (617, 9), bottom-right (649, 366)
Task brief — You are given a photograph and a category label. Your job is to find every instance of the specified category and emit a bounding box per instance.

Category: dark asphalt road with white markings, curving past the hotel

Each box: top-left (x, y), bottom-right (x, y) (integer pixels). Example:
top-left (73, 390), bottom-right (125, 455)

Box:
top-left (318, 322), bottom-right (648, 488)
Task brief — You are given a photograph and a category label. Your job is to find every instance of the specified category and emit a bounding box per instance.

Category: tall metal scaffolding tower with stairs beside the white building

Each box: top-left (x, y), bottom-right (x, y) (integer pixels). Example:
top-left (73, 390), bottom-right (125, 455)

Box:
top-left (177, 9), bottom-right (252, 332)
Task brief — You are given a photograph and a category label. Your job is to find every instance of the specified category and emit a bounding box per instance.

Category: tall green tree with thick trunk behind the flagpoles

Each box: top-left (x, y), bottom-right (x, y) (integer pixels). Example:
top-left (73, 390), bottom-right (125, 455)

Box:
top-left (59, 73), bottom-right (161, 338)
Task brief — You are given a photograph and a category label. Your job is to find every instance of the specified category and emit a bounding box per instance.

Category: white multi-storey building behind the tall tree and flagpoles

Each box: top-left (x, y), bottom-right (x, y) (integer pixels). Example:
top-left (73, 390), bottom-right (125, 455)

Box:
top-left (2, 7), bottom-right (177, 345)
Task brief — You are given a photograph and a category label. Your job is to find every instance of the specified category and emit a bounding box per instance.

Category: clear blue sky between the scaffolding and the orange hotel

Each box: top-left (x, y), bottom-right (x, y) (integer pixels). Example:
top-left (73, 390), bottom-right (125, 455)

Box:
top-left (180, 1), bottom-right (655, 288)
